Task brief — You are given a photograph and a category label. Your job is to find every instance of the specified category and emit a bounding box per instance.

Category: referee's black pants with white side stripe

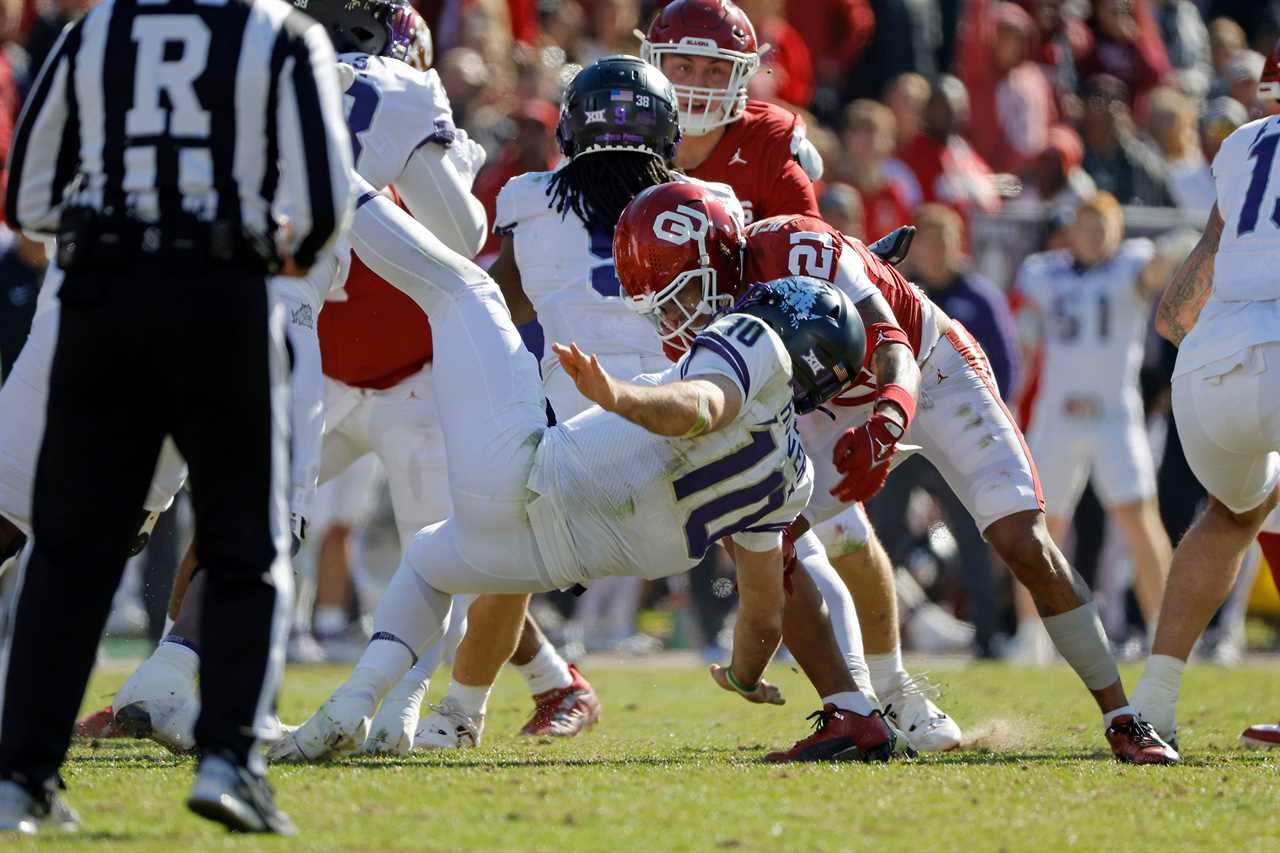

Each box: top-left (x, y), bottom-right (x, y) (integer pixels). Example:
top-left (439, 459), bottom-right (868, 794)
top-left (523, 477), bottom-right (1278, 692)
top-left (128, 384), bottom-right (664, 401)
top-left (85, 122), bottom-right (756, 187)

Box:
top-left (0, 263), bottom-right (293, 789)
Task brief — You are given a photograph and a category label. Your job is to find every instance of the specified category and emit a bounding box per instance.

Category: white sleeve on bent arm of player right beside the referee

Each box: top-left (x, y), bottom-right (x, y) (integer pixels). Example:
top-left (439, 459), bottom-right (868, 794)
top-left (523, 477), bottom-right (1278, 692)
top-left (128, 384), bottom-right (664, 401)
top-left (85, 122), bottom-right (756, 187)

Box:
top-left (396, 145), bottom-right (489, 257)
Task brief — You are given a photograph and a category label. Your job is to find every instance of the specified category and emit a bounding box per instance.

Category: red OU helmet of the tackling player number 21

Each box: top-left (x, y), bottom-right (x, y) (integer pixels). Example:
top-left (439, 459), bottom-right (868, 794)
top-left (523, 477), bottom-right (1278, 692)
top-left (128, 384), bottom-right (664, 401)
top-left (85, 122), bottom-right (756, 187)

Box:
top-left (613, 183), bottom-right (746, 361)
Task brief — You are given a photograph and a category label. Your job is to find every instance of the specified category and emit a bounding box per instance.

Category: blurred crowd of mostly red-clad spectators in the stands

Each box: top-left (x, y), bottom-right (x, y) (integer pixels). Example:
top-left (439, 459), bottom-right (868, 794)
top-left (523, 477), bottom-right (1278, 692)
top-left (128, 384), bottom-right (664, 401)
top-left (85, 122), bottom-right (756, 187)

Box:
top-left (409, 0), bottom-right (1280, 258)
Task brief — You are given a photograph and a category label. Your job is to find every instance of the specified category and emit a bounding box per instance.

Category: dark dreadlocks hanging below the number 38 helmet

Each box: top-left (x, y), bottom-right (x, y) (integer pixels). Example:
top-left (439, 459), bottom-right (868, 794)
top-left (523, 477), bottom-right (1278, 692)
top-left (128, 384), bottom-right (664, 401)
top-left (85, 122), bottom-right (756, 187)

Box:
top-left (547, 151), bottom-right (675, 232)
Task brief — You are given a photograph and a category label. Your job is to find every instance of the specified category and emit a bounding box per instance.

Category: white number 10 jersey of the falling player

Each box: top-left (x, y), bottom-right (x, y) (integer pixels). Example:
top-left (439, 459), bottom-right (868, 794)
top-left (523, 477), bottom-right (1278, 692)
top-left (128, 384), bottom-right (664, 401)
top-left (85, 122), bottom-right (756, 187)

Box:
top-left (529, 314), bottom-right (813, 585)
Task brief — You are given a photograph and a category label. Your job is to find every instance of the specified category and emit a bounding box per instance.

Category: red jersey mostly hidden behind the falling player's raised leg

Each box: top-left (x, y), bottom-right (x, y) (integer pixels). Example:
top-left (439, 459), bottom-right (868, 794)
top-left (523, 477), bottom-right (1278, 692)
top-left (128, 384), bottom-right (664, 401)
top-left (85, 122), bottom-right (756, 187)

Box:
top-left (319, 252), bottom-right (431, 391)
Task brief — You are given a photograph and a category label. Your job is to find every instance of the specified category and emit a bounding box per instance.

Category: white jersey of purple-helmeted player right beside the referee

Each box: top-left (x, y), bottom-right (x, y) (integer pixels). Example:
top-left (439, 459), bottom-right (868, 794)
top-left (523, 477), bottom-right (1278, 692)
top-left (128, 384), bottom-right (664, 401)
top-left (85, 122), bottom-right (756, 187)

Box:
top-left (338, 54), bottom-right (457, 190)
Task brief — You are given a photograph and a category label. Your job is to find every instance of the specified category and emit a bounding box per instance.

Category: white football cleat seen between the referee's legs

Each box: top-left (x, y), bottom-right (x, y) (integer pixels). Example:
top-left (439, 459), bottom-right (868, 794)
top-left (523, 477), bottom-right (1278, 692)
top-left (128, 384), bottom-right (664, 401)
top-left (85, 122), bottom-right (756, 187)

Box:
top-left (111, 643), bottom-right (200, 753)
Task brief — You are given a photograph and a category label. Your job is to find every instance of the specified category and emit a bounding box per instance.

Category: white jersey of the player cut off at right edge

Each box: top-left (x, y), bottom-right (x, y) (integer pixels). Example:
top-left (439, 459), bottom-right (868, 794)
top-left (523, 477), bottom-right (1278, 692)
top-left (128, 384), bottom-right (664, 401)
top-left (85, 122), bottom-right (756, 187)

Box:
top-left (1174, 115), bottom-right (1280, 377)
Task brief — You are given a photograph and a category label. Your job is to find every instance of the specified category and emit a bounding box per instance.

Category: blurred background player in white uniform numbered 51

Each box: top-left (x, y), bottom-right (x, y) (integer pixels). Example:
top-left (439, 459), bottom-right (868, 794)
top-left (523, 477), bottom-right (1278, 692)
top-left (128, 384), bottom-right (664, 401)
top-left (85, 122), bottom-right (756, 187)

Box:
top-left (1016, 192), bottom-right (1174, 650)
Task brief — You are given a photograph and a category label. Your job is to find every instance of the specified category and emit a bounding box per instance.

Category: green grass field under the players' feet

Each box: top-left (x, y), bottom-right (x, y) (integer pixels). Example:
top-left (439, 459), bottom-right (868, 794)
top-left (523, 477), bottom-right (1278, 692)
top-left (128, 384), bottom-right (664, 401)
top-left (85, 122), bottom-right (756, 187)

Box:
top-left (27, 665), bottom-right (1280, 853)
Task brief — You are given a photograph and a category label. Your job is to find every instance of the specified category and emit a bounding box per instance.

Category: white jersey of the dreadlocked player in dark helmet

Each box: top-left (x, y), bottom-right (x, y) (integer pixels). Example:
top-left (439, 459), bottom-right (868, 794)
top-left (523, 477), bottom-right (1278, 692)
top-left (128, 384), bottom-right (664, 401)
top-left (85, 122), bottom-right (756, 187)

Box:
top-left (494, 164), bottom-right (742, 366)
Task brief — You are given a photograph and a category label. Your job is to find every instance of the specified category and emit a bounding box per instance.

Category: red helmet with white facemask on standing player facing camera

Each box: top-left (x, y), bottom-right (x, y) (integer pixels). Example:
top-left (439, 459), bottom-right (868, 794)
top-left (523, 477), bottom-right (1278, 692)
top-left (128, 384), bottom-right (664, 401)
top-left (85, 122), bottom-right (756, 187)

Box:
top-left (640, 0), bottom-right (763, 136)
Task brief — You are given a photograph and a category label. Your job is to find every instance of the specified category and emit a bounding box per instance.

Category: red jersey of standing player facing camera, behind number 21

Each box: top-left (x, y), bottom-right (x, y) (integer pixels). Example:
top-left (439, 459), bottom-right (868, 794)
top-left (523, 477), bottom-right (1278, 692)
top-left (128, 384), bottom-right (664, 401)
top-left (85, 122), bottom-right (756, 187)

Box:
top-left (687, 100), bottom-right (820, 223)
